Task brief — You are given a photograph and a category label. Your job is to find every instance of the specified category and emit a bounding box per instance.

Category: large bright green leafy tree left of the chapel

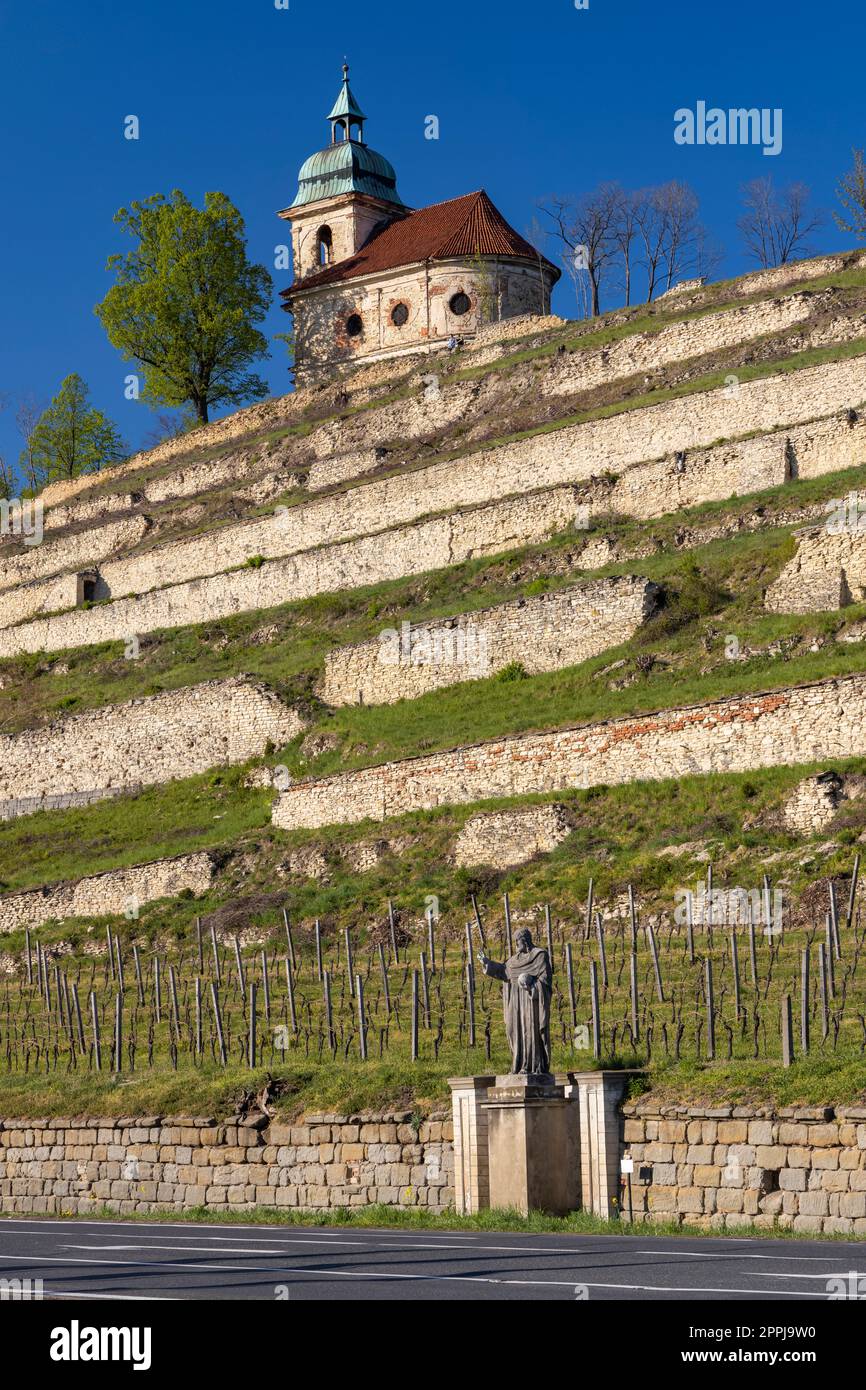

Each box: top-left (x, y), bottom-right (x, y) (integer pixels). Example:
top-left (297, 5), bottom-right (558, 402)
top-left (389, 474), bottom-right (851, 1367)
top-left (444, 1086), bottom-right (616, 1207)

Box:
top-left (96, 189), bottom-right (272, 424)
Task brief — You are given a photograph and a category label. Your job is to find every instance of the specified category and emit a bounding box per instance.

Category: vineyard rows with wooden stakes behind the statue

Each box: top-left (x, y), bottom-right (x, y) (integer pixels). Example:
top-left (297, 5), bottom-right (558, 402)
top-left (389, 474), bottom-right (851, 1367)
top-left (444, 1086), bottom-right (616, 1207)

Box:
top-left (0, 858), bottom-right (866, 1112)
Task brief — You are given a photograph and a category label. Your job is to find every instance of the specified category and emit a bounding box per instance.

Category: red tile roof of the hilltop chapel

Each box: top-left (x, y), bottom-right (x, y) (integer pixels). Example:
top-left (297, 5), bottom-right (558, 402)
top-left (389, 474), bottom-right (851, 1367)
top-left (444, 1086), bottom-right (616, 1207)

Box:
top-left (281, 189), bottom-right (560, 297)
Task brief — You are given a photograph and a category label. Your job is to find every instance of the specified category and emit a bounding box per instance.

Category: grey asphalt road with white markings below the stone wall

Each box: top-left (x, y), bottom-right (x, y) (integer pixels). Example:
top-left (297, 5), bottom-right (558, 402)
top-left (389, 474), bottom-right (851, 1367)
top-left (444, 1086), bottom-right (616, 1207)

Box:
top-left (0, 1218), bottom-right (866, 1304)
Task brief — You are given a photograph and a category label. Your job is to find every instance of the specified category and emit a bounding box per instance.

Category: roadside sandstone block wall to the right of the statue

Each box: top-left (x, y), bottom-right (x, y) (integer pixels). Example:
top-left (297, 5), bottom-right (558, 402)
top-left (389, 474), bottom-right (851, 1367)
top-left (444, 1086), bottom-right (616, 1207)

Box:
top-left (623, 1095), bottom-right (866, 1236)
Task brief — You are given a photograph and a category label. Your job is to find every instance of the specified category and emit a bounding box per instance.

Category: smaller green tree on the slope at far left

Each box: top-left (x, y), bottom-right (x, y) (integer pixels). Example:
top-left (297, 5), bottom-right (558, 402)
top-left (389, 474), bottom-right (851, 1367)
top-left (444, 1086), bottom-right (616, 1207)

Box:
top-left (19, 373), bottom-right (128, 487)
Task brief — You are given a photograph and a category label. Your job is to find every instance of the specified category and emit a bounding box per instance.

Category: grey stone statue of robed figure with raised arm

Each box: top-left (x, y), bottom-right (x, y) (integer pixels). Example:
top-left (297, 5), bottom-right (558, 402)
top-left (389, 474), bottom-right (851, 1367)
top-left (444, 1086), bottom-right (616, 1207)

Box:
top-left (478, 929), bottom-right (553, 1076)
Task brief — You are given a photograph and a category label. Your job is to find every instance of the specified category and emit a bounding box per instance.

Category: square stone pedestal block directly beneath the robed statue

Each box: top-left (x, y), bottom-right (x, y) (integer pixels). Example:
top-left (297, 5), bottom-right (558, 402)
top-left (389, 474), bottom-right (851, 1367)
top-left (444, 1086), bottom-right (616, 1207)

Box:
top-left (480, 1074), bottom-right (580, 1216)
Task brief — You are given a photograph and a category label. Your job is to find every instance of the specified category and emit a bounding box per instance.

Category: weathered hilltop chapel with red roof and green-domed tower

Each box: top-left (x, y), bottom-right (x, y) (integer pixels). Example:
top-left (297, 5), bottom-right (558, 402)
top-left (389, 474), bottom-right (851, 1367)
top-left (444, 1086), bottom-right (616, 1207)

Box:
top-left (278, 64), bottom-right (560, 385)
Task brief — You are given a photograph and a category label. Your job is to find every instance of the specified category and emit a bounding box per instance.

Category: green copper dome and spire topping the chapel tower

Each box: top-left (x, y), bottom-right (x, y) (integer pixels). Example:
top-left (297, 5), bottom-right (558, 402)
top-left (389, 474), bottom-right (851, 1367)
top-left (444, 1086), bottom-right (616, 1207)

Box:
top-left (292, 65), bottom-right (403, 207)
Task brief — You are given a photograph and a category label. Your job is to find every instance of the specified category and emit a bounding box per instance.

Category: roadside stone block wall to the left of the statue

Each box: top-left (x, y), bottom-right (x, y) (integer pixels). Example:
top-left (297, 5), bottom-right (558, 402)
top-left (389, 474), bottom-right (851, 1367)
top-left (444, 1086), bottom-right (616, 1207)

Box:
top-left (0, 1111), bottom-right (455, 1215)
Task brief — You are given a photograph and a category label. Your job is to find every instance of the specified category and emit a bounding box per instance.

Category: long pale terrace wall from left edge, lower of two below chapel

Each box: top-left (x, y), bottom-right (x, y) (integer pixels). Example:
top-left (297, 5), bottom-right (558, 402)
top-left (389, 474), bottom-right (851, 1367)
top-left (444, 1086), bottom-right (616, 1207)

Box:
top-left (0, 488), bottom-right (578, 656)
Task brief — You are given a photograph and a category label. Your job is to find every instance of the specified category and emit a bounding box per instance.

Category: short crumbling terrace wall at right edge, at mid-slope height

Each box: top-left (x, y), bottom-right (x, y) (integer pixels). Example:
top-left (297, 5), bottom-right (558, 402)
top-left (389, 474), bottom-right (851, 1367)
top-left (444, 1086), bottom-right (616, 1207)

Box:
top-left (765, 519), bottom-right (866, 613)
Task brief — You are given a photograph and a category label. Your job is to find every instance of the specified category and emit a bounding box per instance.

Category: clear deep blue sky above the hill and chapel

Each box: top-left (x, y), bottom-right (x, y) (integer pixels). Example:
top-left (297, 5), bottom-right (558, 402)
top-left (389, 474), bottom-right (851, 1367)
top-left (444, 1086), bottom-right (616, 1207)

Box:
top-left (0, 0), bottom-right (866, 478)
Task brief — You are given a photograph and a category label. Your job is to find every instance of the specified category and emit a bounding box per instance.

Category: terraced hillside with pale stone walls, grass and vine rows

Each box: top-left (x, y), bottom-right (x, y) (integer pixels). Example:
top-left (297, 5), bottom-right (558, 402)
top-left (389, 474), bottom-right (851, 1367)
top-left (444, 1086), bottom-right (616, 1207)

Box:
top-left (0, 254), bottom-right (866, 1115)
